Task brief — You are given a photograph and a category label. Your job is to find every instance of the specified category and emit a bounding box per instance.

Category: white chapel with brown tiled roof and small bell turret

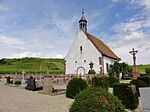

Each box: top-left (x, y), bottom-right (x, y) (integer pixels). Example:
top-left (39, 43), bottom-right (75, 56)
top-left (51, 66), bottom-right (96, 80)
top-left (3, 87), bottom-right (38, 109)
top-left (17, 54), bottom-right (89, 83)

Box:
top-left (65, 12), bottom-right (119, 76)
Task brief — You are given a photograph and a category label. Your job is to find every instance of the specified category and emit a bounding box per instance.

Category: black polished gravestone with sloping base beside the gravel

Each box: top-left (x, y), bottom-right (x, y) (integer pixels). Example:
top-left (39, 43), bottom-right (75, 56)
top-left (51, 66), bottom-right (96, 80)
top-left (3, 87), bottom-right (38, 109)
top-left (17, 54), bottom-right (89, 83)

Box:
top-left (25, 76), bottom-right (43, 91)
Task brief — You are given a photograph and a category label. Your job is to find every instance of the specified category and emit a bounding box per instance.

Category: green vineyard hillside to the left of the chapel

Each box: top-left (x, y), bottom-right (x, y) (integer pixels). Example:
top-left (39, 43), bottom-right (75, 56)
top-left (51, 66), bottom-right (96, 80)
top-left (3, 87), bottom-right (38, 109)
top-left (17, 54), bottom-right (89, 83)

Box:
top-left (0, 58), bottom-right (64, 74)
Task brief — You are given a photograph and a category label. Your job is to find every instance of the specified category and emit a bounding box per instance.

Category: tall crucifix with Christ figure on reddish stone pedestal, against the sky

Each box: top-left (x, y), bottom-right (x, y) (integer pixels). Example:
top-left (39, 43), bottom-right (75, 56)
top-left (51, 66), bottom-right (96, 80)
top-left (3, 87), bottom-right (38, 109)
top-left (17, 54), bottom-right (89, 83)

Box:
top-left (129, 48), bottom-right (138, 79)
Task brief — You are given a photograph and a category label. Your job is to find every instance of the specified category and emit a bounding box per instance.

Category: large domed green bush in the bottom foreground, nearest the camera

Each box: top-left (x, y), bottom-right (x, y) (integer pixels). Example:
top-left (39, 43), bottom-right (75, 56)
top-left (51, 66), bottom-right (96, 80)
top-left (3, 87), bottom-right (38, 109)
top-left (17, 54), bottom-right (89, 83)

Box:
top-left (69, 87), bottom-right (125, 112)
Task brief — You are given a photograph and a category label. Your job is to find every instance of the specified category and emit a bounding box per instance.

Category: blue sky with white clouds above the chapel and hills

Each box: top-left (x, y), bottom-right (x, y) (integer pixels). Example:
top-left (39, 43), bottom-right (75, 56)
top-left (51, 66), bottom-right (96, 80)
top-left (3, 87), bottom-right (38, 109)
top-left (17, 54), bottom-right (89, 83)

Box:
top-left (0, 0), bottom-right (150, 64)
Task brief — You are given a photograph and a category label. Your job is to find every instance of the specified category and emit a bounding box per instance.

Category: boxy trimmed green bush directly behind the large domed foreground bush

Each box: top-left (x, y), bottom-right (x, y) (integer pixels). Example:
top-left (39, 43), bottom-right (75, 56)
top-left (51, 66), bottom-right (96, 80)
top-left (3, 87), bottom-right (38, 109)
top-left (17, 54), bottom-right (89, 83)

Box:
top-left (92, 76), bottom-right (109, 90)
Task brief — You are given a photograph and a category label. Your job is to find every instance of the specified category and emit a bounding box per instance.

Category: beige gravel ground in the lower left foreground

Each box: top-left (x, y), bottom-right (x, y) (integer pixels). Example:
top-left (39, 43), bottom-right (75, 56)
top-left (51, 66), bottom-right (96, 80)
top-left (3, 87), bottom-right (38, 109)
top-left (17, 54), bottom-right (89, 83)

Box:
top-left (0, 79), bottom-right (73, 112)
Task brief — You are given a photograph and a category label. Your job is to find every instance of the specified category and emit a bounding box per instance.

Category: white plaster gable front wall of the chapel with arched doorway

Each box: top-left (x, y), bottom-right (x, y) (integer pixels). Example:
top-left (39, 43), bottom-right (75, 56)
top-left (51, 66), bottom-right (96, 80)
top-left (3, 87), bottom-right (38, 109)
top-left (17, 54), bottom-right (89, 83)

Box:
top-left (65, 30), bottom-right (102, 74)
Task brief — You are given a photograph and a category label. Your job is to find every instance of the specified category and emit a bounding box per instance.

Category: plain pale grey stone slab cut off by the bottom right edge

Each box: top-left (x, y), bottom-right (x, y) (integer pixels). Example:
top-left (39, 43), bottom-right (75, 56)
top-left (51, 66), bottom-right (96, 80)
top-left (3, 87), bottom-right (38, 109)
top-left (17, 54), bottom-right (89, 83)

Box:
top-left (139, 87), bottom-right (150, 112)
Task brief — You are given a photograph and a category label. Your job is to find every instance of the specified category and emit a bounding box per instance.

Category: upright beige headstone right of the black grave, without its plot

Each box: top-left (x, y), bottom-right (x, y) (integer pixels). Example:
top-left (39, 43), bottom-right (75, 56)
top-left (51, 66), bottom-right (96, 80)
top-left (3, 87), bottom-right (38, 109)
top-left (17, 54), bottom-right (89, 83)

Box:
top-left (42, 76), bottom-right (53, 94)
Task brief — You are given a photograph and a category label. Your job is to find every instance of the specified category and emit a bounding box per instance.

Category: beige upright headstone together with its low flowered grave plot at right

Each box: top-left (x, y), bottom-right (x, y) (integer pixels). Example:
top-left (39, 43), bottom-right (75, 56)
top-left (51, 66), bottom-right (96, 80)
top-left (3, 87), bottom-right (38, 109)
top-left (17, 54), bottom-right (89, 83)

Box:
top-left (41, 76), bottom-right (65, 96)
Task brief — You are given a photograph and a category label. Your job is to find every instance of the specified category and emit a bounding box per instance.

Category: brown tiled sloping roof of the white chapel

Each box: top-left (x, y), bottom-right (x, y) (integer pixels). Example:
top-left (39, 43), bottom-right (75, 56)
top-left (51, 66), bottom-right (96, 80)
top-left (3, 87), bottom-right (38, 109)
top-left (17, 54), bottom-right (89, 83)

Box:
top-left (85, 33), bottom-right (120, 60)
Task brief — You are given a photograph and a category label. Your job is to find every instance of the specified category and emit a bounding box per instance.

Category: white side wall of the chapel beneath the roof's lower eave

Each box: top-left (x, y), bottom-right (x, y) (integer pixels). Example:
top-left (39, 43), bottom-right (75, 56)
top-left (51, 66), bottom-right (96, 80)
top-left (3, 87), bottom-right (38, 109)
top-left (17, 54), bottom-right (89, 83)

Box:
top-left (103, 56), bottom-right (116, 74)
